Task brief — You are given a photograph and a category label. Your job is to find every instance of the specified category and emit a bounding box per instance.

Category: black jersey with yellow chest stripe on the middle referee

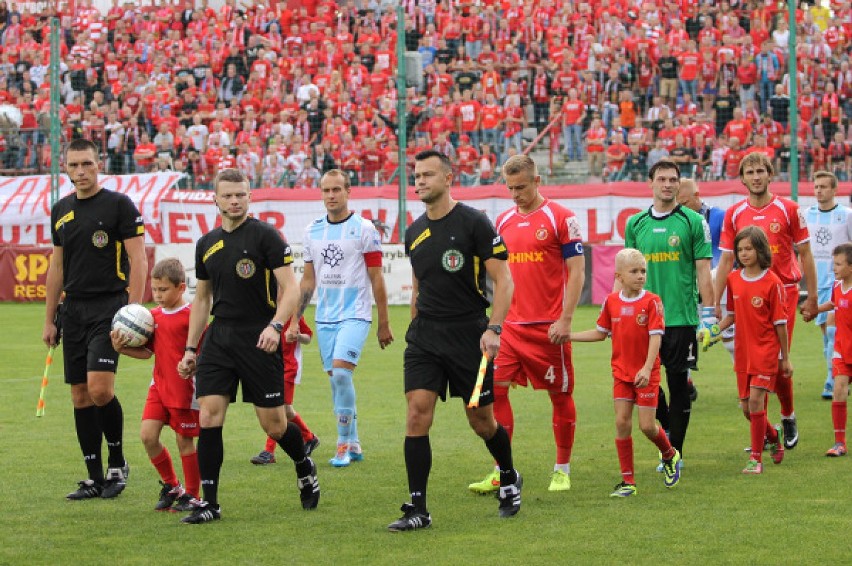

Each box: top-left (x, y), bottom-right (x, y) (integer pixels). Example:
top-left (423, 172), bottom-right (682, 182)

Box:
top-left (195, 218), bottom-right (293, 326)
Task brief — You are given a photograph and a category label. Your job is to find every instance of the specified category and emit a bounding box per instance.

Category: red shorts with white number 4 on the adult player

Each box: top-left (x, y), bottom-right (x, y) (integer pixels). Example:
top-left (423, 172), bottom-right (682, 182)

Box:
top-left (494, 322), bottom-right (574, 395)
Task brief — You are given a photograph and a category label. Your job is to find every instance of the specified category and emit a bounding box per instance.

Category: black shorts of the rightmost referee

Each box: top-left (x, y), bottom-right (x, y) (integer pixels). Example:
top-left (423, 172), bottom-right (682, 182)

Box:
top-left (404, 316), bottom-right (494, 406)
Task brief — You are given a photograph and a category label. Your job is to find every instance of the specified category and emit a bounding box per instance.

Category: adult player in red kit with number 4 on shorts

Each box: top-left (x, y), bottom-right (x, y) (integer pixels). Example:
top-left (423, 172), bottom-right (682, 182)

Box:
top-left (469, 155), bottom-right (585, 493)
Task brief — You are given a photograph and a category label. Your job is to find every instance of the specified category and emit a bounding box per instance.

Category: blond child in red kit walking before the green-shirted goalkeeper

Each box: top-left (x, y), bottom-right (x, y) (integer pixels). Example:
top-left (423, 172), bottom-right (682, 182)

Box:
top-left (571, 248), bottom-right (681, 497)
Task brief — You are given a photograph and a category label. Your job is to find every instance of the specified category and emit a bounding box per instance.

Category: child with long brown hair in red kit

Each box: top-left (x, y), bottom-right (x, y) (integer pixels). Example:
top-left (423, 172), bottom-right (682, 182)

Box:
top-left (719, 226), bottom-right (793, 474)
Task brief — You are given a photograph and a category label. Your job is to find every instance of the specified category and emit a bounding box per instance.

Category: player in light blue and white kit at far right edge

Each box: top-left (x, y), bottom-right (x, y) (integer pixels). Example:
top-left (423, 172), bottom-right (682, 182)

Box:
top-left (805, 171), bottom-right (852, 399)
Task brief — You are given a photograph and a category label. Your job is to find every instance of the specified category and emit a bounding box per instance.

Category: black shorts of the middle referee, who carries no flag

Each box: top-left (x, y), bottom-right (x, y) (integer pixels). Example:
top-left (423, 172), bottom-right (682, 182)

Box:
top-left (195, 320), bottom-right (284, 407)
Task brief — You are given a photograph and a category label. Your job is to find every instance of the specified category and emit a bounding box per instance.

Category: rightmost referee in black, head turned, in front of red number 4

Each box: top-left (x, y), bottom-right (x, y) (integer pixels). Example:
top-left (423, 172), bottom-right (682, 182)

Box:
top-left (388, 150), bottom-right (522, 531)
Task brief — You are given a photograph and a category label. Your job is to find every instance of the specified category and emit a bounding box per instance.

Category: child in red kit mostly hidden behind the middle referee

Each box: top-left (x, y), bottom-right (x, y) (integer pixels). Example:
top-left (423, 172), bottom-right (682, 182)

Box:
top-left (251, 317), bottom-right (319, 466)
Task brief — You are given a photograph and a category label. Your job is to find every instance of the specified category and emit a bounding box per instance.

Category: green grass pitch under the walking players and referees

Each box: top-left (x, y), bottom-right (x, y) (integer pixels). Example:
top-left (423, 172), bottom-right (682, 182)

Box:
top-left (0, 304), bottom-right (852, 565)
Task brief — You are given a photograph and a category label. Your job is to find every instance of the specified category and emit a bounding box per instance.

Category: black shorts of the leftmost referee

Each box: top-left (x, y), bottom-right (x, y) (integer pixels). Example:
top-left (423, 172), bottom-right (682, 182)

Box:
top-left (61, 293), bottom-right (127, 385)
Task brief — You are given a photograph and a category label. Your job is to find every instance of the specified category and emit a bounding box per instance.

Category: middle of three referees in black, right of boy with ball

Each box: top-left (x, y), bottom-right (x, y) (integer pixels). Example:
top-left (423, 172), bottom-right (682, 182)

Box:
top-left (178, 169), bottom-right (320, 523)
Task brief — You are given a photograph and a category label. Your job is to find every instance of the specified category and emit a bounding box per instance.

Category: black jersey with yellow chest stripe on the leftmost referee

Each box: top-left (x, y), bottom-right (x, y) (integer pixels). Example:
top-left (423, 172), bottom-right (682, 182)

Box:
top-left (50, 189), bottom-right (145, 299)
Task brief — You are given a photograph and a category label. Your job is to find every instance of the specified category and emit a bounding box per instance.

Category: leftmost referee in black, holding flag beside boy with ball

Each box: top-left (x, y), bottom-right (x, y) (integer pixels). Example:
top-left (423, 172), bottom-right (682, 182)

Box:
top-left (42, 139), bottom-right (148, 499)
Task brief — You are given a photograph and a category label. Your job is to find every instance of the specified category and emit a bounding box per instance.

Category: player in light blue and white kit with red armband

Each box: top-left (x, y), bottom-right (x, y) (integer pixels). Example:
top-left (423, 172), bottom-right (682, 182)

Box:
top-left (288, 169), bottom-right (393, 468)
